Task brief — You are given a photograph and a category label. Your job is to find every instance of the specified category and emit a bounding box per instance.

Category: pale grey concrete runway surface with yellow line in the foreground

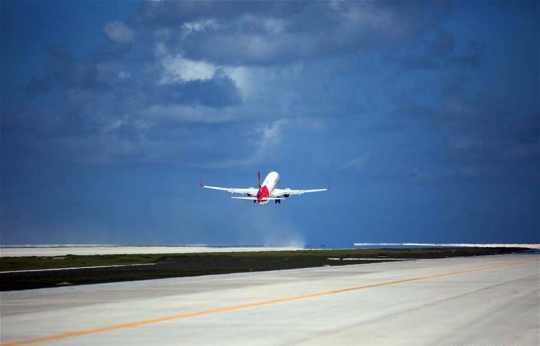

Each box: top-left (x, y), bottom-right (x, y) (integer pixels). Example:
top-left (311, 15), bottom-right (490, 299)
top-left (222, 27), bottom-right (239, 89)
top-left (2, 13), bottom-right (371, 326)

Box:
top-left (0, 254), bottom-right (540, 346)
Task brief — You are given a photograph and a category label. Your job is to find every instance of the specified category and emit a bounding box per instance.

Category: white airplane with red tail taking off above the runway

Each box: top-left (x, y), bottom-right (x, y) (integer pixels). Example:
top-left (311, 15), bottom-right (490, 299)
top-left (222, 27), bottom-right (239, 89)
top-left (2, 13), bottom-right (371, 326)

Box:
top-left (199, 171), bottom-right (330, 205)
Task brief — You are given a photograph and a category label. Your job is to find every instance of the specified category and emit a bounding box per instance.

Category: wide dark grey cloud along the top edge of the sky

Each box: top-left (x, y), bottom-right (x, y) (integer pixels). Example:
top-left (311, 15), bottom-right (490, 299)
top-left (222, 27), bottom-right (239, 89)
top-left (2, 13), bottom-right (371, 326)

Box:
top-left (136, 1), bottom-right (449, 65)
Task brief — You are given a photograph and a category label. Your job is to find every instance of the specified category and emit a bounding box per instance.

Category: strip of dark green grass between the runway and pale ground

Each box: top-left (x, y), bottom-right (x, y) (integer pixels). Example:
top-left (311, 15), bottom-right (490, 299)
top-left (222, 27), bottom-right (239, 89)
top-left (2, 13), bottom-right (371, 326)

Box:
top-left (0, 248), bottom-right (521, 291)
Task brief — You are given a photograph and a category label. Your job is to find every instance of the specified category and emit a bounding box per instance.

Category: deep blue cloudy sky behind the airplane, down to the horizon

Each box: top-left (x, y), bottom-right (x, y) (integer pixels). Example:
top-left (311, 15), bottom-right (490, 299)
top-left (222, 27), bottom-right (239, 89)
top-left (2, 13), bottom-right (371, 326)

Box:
top-left (0, 0), bottom-right (540, 247)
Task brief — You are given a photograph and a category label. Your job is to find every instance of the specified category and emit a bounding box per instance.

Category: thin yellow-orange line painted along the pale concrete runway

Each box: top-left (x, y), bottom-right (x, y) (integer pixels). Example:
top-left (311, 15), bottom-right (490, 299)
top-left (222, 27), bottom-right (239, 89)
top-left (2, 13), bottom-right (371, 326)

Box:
top-left (0, 260), bottom-right (538, 346)
